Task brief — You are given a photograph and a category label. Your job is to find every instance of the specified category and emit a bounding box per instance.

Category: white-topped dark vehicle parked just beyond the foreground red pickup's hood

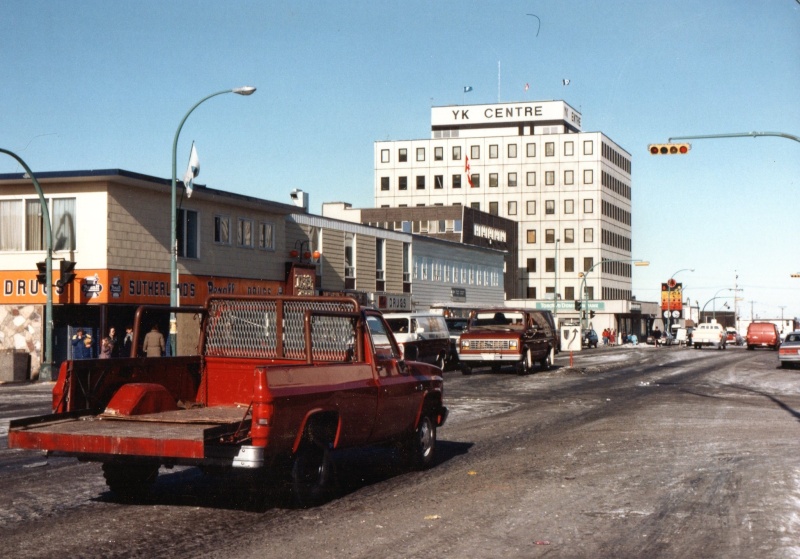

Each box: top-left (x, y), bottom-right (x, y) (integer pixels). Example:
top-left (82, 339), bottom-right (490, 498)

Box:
top-left (383, 313), bottom-right (450, 369)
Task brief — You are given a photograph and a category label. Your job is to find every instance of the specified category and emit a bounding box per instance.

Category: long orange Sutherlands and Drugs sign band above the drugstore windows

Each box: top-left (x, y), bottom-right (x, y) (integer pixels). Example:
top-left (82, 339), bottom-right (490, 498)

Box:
top-left (0, 270), bottom-right (284, 305)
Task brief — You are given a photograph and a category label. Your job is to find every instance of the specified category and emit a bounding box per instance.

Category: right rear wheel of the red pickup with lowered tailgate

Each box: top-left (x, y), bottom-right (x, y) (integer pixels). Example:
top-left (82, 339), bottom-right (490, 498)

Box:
top-left (291, 440), bottom-right (334, 508)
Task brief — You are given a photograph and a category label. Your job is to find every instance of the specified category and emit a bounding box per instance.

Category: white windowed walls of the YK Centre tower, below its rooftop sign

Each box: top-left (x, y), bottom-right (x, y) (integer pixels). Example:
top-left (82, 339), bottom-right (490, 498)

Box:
top-left (374, 121), bottom-right (631, 308)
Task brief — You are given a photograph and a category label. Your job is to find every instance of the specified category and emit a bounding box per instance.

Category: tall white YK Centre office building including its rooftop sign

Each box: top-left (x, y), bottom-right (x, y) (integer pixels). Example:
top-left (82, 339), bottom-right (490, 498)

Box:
top-left (374, 101), bottom-right (632, 328)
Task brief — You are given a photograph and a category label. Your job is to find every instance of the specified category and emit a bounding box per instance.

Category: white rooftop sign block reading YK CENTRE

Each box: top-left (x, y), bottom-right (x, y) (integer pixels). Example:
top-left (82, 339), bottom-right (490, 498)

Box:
top-left (431, 101), bottom-right (581, 130)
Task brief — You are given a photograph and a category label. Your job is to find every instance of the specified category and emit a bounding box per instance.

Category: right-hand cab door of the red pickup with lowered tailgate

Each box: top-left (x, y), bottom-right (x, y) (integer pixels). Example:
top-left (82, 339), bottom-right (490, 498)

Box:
top-left (367, 314), bottom-right (423, 440)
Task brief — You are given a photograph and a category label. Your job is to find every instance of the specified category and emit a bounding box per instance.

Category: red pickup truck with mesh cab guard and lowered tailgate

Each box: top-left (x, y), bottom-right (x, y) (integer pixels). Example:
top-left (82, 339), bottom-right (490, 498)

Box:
top-left (8, 296), bottom-right (447, 506)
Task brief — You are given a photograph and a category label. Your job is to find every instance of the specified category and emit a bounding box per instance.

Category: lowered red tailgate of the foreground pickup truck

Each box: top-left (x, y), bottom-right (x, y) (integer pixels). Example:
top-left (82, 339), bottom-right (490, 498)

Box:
top-left (8, 406), bottom-right (250, 460)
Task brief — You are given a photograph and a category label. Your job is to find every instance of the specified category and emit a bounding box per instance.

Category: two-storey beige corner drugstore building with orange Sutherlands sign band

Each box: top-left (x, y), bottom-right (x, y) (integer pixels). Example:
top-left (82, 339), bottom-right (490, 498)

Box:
top-left (0, 169), bottom-right (297, 371)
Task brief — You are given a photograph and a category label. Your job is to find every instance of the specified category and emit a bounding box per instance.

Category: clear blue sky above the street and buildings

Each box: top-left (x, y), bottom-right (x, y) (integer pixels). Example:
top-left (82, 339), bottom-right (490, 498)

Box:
top-left (0, 0), bottom-right (800, 319)
